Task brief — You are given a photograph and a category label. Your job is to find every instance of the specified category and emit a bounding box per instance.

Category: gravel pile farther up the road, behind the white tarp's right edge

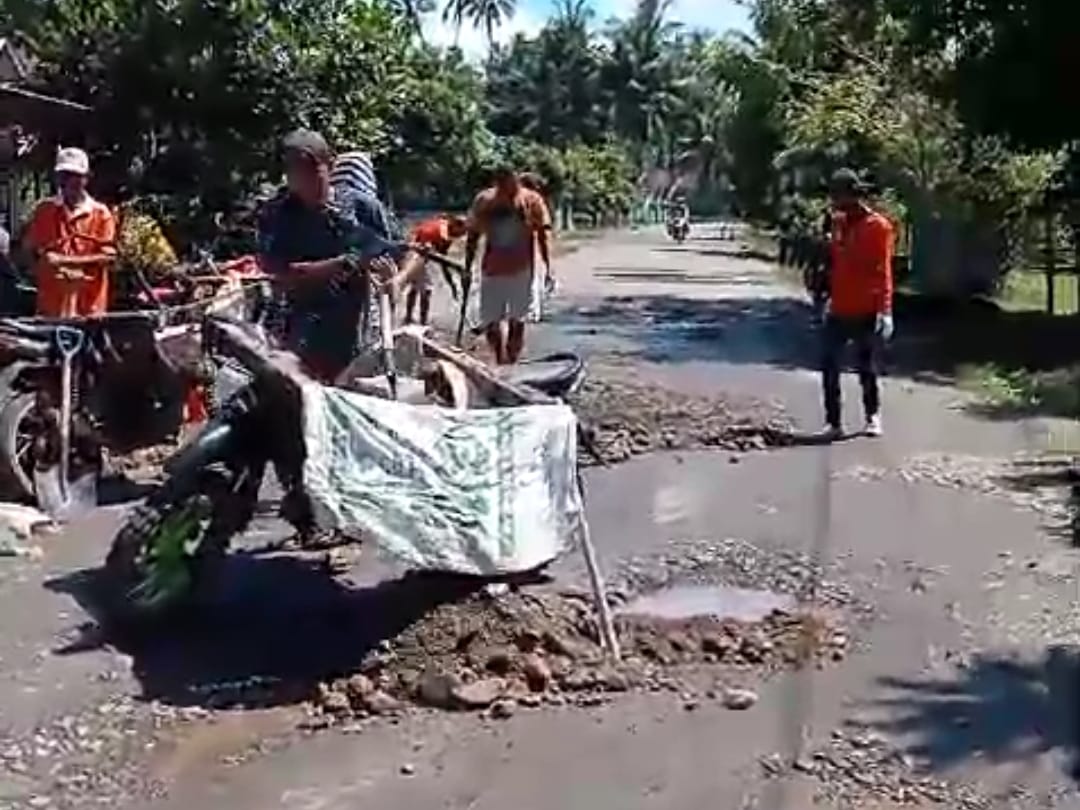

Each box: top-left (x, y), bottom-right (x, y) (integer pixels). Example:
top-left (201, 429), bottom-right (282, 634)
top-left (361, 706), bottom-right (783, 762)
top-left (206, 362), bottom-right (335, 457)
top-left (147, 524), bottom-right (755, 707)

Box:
top-left (570, 370), bottom-right (792, 463)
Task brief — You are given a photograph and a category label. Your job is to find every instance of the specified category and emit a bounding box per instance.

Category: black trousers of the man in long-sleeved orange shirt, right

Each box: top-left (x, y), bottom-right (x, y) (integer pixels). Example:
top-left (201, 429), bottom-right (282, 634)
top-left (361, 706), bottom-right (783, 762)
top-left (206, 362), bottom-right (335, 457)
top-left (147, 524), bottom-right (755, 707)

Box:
top-left (821, 315), bottom-right (881, 428)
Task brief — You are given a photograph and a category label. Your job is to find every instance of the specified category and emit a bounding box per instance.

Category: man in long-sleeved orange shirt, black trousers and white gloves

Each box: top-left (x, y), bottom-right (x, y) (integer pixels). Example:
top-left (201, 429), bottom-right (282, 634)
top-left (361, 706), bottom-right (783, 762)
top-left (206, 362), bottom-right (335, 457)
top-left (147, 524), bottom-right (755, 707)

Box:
top-left (822, 168), bottom-right (895, 438)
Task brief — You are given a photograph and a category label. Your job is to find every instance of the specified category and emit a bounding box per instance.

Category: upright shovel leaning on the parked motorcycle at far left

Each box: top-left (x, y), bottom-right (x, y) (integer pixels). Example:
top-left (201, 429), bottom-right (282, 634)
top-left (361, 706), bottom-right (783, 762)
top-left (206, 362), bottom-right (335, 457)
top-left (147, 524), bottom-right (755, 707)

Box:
top-left (33, 326), bottom-right (97, 519)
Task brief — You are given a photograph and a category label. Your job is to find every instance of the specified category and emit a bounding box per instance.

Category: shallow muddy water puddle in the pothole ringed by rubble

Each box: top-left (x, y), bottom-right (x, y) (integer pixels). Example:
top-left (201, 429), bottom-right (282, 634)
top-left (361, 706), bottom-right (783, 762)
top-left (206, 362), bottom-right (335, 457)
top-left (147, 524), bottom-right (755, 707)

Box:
top-left (619, 585), bottom-right (796, 622)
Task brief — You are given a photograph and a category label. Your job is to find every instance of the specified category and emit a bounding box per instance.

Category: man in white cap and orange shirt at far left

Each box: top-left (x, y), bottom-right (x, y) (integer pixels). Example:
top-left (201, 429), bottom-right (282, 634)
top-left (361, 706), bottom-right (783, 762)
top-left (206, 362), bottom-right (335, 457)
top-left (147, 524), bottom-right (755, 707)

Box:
top-left (24, 148), bottom-right (117, 318)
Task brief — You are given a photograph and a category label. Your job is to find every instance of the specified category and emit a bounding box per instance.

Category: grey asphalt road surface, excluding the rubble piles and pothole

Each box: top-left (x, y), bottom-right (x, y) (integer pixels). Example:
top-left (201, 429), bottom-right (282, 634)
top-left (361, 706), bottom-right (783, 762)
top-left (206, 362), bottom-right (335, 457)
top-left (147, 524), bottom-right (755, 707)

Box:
top-left (0, 227), bottom-right (1080, 810)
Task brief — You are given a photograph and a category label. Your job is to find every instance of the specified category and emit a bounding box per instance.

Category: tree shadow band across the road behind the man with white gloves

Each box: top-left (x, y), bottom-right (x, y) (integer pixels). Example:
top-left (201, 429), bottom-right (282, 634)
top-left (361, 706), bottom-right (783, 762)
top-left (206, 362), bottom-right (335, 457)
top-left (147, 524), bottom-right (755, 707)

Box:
top-left (561, 285), bottom-right (1080, 418)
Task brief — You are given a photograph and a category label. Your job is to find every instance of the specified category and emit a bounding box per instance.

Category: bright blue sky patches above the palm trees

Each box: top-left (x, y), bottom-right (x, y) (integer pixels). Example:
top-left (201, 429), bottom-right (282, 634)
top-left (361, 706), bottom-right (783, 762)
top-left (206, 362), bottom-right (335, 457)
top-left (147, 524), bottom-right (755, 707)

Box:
top-left (424, 0), bottom-right (750, 57)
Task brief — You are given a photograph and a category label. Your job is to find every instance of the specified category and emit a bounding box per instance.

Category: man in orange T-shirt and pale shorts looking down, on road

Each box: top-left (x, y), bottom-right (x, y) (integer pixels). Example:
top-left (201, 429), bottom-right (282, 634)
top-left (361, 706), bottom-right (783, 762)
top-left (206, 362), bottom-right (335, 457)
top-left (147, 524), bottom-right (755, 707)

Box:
top-left (465, 166), bottom-right (553, 365)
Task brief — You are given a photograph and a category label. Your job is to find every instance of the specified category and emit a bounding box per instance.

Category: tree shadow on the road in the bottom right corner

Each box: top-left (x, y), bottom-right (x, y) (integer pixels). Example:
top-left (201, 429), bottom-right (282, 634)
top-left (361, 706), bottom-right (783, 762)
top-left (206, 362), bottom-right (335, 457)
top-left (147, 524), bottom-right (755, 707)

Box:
top-left (875, 647), bottom-right (1080, 779)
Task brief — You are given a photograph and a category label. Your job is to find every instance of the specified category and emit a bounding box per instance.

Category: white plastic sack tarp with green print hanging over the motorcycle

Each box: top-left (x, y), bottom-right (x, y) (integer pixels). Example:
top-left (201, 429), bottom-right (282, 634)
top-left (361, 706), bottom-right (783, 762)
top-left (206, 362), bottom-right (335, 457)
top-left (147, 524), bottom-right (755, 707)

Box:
top-left (302, 383), bottom-right (584, 576)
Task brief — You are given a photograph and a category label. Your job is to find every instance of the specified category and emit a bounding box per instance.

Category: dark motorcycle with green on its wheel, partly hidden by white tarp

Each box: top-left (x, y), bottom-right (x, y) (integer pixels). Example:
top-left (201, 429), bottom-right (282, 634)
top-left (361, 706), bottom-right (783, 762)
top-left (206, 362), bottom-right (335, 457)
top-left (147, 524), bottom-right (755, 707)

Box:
top-left (105, 319), bottom-right (584, 623)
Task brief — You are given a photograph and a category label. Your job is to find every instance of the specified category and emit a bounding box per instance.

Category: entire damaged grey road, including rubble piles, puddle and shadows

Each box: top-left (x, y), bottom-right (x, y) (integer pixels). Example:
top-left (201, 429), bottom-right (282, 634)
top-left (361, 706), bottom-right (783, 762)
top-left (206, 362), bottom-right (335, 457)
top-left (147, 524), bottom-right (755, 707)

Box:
top-left (0, 227), bottom-right (1080, 810)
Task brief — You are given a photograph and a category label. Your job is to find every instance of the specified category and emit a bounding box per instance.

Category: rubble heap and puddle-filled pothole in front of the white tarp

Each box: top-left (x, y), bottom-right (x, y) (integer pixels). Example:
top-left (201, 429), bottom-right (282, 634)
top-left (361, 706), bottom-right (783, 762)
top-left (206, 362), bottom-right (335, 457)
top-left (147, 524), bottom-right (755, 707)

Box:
top-left (313, 546), bottom-right (849, 725)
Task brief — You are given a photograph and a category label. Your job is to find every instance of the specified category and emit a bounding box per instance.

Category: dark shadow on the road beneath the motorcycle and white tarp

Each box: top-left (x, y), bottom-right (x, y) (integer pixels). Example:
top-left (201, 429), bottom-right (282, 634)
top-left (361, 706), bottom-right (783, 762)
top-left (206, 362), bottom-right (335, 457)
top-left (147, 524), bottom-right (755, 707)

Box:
top-left (46, 554), bottom-right (480, 708)
